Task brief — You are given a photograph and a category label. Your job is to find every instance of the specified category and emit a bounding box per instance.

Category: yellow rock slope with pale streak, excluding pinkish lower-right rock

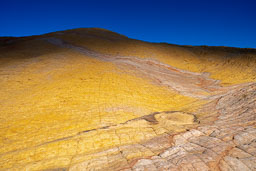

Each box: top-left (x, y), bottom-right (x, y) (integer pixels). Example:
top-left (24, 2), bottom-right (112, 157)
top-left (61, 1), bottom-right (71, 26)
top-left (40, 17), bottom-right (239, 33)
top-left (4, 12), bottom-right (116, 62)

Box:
top-left (0, 29), bottom-right (256, 170)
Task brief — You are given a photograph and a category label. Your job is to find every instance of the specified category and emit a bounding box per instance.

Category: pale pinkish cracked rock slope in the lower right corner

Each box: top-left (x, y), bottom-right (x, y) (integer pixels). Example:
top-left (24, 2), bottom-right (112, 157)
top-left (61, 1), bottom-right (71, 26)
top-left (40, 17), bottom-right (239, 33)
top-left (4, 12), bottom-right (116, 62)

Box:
top-left (128, 84), bottom-right (256, 170)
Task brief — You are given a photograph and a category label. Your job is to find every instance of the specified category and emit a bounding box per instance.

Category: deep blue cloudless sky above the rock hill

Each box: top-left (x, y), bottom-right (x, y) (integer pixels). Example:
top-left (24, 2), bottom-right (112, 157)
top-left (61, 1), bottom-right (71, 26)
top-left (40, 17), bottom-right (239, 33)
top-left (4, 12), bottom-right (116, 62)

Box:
top-left (0, 0), bottom-right (256, 48)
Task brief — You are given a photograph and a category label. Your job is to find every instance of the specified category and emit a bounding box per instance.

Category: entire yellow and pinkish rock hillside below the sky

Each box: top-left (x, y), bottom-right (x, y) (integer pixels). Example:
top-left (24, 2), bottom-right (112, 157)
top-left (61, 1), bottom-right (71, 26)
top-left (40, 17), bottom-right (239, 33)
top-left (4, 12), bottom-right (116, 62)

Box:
top-left (0, 29), bottom-right (256, 171)
